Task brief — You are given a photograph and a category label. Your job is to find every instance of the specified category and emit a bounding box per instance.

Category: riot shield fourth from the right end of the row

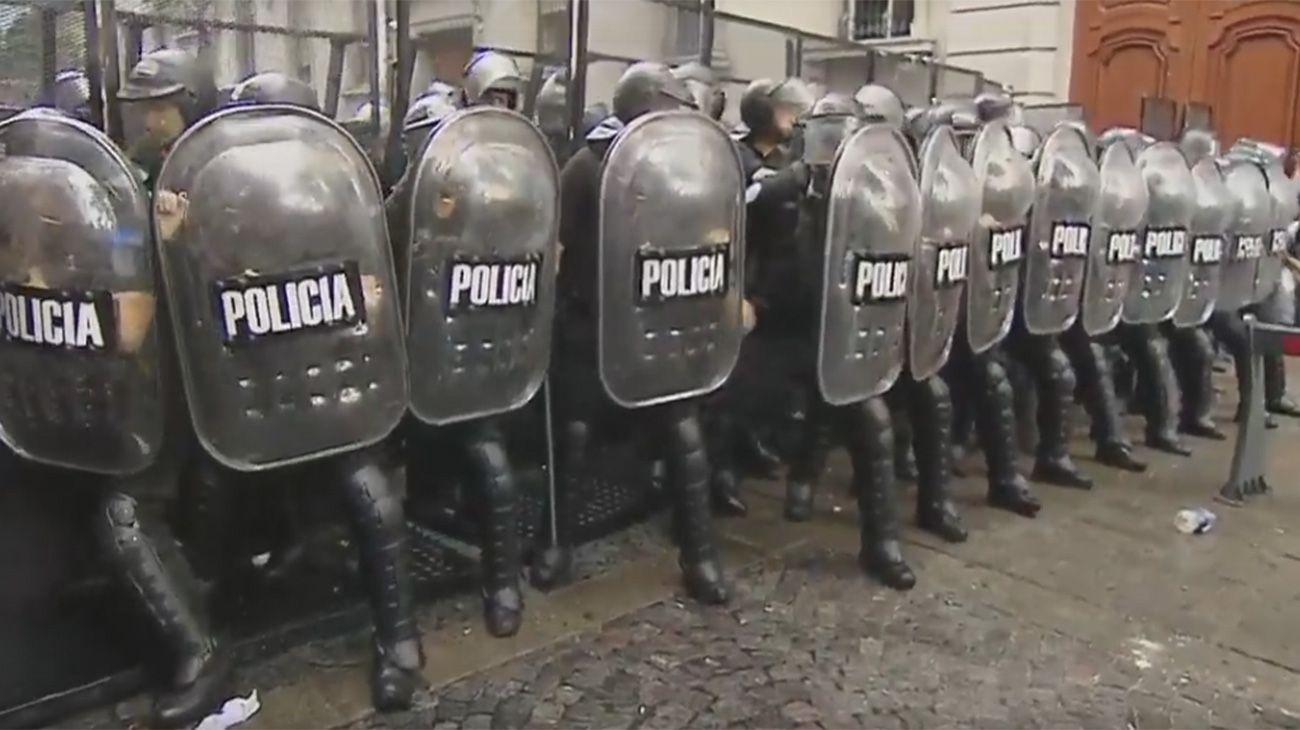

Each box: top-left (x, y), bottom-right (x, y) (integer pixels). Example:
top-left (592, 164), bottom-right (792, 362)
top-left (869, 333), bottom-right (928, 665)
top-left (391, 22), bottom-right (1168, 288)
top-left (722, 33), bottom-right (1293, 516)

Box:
top-left (1123, 142), bottom-right (1196, 325)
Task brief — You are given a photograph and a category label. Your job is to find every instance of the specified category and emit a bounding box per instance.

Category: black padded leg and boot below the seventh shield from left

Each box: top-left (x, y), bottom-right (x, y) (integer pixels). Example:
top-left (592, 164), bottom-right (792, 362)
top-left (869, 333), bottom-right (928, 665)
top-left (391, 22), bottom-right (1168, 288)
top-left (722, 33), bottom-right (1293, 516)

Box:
top-left (971, 353), bottom-right (1043, 517)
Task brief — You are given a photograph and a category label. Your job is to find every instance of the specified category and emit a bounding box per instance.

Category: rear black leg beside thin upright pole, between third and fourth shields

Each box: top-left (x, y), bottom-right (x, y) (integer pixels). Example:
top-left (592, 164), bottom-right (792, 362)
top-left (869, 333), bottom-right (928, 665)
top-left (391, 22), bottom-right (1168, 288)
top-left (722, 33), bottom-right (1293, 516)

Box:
top-left (530, 420), bottom-right (592, 590)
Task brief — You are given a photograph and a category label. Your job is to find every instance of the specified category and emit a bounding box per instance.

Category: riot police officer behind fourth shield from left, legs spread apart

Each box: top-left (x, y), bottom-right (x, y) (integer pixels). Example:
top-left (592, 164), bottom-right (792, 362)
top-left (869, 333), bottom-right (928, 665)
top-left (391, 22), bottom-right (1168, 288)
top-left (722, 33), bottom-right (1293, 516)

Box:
top-left (534, 62), bottom-right (744, 604)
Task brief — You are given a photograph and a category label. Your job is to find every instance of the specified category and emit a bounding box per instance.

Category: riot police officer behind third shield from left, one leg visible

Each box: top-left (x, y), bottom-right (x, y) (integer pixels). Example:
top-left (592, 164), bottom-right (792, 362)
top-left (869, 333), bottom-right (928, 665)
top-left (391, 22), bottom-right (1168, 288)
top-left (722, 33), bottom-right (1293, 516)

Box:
top-left (389, 65), bottom-right (543, 636)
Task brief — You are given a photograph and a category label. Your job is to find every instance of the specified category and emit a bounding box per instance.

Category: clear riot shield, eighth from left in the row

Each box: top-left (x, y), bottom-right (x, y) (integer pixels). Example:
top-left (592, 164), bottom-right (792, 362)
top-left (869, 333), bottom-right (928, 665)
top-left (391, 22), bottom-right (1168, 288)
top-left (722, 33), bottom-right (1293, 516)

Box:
top-left (1021, 122), bottom-right (1101, 335)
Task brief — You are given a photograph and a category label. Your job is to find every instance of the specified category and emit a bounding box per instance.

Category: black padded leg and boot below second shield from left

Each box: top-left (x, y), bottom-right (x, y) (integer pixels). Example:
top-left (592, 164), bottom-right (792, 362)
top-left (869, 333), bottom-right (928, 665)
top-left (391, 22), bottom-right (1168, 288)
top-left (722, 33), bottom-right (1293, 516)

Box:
top-left (339, 448), bottom-right (424, 712)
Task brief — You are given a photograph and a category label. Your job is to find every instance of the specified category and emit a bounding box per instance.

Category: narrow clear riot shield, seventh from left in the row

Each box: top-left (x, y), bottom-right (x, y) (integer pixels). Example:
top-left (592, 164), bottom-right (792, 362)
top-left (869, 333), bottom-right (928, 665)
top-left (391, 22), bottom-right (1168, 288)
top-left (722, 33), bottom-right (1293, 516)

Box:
top-left (966, 120), bottom-right (1034, 353)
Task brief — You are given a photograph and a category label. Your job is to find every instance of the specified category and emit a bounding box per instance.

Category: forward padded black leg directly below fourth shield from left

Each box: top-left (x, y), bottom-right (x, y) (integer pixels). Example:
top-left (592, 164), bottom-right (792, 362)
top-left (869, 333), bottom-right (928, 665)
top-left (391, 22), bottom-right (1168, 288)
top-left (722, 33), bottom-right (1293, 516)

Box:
top-left (659, 404), bottom-right (729, 604)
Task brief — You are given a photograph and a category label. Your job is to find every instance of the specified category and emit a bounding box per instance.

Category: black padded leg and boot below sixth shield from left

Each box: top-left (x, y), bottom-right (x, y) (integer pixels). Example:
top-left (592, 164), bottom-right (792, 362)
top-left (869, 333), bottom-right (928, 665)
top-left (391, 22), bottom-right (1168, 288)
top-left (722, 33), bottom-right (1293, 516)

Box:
top-left (909, 375), bottom-right (967, 543)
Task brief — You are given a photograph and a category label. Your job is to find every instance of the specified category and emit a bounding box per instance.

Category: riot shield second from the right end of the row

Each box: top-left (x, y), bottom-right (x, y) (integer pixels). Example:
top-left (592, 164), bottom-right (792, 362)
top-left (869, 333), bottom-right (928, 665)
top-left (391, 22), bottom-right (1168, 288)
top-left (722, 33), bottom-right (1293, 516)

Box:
top-left (1214, 157), bottom-right (1273, 312)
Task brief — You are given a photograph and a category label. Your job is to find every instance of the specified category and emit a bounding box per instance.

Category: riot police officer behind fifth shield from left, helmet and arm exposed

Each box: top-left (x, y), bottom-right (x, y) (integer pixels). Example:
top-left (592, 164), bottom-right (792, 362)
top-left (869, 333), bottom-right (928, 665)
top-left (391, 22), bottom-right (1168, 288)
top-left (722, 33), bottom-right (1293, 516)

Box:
top-left (741, 79), bottom-right (920, 590)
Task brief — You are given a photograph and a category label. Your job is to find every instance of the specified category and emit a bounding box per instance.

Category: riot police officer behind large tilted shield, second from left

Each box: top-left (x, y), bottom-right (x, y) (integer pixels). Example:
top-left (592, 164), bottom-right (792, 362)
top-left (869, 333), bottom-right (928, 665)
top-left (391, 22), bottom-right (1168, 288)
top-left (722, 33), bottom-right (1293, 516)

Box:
top-left (146, 58), bottom-right (424, 711)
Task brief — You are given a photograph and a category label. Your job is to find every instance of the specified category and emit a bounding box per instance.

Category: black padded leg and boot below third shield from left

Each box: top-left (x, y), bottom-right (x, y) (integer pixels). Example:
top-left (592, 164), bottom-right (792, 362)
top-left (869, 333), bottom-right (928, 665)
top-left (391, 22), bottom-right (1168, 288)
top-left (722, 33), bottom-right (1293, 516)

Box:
top-left (464, 423), bottom-right (524, 636)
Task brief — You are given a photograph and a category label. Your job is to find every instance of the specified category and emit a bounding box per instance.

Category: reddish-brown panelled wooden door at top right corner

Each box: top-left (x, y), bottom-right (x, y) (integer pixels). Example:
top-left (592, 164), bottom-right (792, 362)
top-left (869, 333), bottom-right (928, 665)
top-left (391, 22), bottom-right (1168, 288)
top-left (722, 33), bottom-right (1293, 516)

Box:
top-left (1070, 0), bottom-right (1300, 145)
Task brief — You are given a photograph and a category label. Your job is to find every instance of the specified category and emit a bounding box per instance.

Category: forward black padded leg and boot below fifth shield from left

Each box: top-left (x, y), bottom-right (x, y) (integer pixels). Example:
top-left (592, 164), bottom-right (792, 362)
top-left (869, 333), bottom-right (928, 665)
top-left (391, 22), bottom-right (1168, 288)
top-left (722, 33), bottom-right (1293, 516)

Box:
top-left (836, 397), bottom-right (917, 591)
